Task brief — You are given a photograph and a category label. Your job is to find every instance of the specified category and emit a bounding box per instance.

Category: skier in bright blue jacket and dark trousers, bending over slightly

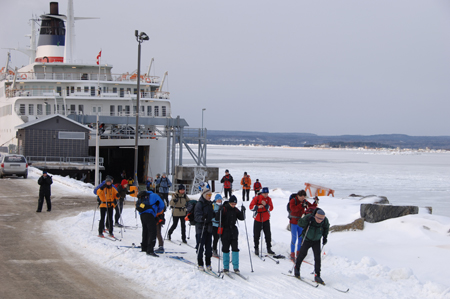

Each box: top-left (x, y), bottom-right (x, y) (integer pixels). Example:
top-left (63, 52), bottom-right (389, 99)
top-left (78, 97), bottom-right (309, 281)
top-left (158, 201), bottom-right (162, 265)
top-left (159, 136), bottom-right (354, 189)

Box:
top-left (137, 191), bottom-right (165, 257)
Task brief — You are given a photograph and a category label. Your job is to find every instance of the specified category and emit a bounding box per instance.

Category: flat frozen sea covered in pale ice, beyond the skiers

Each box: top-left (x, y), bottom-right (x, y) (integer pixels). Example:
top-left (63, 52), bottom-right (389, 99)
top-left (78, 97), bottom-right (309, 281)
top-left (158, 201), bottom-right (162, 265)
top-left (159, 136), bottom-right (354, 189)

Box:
top-left (184, 145), bottom-right (450, 216)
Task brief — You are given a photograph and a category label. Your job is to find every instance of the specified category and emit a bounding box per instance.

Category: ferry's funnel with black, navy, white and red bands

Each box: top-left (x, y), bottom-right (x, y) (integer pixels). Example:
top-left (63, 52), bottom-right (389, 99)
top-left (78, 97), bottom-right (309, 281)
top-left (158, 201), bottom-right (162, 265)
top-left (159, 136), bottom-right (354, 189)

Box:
top-left (35, 2), bottom-right (66, 63)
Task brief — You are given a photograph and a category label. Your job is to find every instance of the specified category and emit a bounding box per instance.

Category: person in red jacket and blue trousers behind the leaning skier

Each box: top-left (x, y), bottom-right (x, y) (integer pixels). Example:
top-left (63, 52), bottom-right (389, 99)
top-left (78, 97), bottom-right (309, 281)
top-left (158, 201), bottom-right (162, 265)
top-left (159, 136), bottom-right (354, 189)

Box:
top-left (289, 190), bottom-right (319, 262)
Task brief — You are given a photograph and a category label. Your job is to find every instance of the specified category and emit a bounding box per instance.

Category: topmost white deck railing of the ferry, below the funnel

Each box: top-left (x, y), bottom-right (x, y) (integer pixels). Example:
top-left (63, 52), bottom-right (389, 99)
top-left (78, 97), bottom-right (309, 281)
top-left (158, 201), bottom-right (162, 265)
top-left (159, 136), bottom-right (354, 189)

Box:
top-left (14, 72), bottom-right (160, 84)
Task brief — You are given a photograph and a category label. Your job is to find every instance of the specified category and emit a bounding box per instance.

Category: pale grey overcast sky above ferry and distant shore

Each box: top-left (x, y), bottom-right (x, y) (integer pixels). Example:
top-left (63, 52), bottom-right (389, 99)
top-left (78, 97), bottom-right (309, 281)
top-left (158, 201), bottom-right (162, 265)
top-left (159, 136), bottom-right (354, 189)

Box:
top-left (0, 0), bottom-right (450, 136)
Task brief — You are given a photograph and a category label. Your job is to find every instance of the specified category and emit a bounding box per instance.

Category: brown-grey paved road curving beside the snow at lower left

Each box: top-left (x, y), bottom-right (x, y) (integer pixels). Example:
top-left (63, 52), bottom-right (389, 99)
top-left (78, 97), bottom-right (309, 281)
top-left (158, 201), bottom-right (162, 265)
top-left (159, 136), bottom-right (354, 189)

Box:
top-left (0, 178), bottom-right (150, 298)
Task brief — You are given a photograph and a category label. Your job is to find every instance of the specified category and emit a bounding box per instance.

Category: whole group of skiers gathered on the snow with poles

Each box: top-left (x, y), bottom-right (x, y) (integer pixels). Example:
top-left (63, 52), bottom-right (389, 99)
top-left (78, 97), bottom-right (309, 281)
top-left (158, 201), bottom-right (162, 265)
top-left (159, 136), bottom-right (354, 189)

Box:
top-left (92, 169), bottom-right (330, 283)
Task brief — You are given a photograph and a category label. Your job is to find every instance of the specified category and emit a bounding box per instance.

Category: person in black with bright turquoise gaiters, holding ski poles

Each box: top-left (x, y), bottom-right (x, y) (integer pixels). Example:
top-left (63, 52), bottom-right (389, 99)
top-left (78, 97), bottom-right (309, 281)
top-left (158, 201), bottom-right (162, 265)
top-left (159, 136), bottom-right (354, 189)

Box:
top-left (216, 195), bottom-right (245, 273)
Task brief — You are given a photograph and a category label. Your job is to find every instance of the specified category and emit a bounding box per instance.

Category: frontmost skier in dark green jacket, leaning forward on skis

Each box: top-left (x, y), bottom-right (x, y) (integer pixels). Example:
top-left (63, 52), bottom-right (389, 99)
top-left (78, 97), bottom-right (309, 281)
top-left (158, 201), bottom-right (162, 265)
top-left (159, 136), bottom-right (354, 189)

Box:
top-left (294, 208), bottom-right (330, 284)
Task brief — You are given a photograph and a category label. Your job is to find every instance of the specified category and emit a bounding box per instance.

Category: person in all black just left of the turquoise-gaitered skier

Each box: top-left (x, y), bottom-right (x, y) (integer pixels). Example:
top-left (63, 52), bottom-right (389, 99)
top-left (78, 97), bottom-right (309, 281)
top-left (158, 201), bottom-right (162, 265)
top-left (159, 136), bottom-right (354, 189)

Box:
top-left (194, 189), bottom-right (215, 271)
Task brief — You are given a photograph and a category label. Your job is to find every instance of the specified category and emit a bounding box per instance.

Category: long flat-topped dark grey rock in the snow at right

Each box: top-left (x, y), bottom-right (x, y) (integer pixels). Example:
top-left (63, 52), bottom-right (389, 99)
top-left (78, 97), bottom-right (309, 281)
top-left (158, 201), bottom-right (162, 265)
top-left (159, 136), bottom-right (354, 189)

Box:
top-left (360, 204), bottom-right (419, 223)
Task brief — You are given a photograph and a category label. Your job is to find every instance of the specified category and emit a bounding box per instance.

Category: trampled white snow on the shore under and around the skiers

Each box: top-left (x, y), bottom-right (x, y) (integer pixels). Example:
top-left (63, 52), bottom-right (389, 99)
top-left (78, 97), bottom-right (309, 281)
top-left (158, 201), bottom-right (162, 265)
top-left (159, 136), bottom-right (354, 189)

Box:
top-left (36, 149), bottom-right (450, 298)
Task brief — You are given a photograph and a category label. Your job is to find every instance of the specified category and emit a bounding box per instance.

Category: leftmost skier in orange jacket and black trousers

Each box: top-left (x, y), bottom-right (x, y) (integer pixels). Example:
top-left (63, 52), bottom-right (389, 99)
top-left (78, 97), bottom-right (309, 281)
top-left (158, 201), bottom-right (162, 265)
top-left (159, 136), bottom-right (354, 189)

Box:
top-left (97, 177), bottom-right (120, 238)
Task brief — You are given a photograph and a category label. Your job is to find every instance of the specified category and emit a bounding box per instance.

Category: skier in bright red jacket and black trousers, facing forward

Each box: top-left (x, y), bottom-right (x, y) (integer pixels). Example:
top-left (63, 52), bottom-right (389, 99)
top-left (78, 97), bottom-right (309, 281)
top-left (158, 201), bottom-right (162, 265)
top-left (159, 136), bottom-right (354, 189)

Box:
top-left (249, 187), bottom-right (275, 255)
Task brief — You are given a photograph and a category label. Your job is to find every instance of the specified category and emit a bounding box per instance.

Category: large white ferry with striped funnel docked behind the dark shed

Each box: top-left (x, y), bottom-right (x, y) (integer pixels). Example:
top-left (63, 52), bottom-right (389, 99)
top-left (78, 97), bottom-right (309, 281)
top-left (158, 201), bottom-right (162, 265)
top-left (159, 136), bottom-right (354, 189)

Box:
top-left (0, 0), bottom-right (211, 188)
